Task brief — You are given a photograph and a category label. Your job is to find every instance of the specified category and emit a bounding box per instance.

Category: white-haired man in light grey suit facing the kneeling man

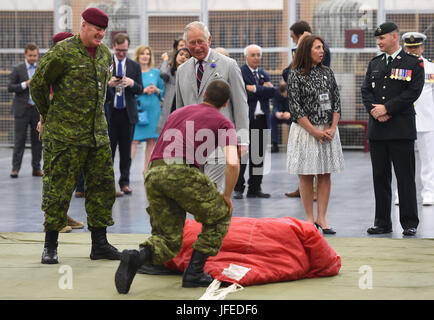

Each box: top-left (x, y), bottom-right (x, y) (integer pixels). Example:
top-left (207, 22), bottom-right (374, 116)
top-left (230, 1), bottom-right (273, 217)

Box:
top-left (176, 21), bottom-right (249, 192)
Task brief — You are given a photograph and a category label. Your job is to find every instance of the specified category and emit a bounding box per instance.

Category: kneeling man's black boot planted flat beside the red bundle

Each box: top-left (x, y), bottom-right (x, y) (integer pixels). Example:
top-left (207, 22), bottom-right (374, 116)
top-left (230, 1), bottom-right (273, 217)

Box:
top-left (182, 250), bottom-right (213, 288)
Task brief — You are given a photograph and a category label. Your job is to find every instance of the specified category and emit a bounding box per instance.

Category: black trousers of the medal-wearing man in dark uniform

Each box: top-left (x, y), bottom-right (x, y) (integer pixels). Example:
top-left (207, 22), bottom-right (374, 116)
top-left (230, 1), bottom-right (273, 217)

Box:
top-left (369, 140), bottom-right (419, 228)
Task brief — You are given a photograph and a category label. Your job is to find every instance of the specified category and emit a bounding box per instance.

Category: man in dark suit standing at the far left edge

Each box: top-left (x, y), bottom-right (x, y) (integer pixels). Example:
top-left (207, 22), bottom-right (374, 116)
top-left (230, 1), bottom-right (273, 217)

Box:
top-left (8, 43), bottom-right (43, 178)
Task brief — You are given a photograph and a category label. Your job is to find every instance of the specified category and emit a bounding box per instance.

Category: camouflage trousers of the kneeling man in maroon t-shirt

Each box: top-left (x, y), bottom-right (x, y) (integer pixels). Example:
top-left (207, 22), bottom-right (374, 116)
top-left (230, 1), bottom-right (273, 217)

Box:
top-left (140, 160), bottom-right (231, 264)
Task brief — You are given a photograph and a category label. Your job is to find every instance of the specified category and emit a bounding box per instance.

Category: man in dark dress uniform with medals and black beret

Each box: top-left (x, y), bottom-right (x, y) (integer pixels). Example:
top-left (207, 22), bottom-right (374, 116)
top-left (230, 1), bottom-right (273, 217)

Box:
top-left (362, 22), bottom-right (425, 236)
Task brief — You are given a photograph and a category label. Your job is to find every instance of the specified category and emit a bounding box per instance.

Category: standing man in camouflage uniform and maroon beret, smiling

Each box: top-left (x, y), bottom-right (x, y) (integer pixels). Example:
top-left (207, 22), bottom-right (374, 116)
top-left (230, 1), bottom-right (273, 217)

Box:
top-left (31, 8), bottom-right (119, 264)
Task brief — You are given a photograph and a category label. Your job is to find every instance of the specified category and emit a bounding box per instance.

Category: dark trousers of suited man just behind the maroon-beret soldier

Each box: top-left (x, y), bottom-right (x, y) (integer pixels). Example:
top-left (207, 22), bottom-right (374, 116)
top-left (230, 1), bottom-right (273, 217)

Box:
top-left (109, 108), bottom-right (135, 188)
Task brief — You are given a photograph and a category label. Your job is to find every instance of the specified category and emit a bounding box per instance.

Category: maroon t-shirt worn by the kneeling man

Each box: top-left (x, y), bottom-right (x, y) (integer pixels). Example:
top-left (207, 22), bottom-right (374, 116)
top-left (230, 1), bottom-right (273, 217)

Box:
top-left (151, 104), bottom-right (237, 167)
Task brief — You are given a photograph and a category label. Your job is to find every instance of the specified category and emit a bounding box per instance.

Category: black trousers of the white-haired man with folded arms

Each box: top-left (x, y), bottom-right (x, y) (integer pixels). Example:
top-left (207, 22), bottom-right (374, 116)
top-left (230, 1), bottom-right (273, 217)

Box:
top-left (235, 115), bottom-right (269, 193)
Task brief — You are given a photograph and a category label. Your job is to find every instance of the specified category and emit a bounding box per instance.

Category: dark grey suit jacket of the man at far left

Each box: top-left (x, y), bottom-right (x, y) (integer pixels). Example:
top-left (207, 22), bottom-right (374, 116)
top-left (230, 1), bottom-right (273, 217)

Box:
top-left (8, 62), bottom-right (36, 117)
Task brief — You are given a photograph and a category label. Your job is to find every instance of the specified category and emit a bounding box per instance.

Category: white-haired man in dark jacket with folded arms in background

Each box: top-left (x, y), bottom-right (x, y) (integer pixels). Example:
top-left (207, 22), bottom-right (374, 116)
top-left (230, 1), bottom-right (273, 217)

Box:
top-left (234, 44), bottom-right (276, 199)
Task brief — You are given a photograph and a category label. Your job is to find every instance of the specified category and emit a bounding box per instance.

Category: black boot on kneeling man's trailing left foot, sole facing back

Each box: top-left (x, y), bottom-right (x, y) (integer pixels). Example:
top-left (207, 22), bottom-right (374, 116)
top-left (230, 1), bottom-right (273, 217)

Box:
top-left (115, 246), bottom-right (152, 293)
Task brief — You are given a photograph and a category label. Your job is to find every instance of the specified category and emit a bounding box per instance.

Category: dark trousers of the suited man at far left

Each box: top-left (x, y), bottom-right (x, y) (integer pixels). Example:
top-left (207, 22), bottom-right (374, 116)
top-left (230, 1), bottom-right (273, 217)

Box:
top-left (12, 105), bottom-right (42, 171)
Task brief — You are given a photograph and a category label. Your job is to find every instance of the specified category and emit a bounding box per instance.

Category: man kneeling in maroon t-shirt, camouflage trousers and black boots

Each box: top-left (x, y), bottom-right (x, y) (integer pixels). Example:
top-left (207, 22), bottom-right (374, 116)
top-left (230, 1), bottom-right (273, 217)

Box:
top-left (115, 80), bottom-right (239, 293)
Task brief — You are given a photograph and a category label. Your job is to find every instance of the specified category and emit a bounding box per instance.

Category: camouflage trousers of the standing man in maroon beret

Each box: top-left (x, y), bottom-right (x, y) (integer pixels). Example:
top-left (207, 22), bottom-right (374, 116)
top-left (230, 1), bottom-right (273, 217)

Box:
top-left (42, 140), bottom-right (116, 231)
